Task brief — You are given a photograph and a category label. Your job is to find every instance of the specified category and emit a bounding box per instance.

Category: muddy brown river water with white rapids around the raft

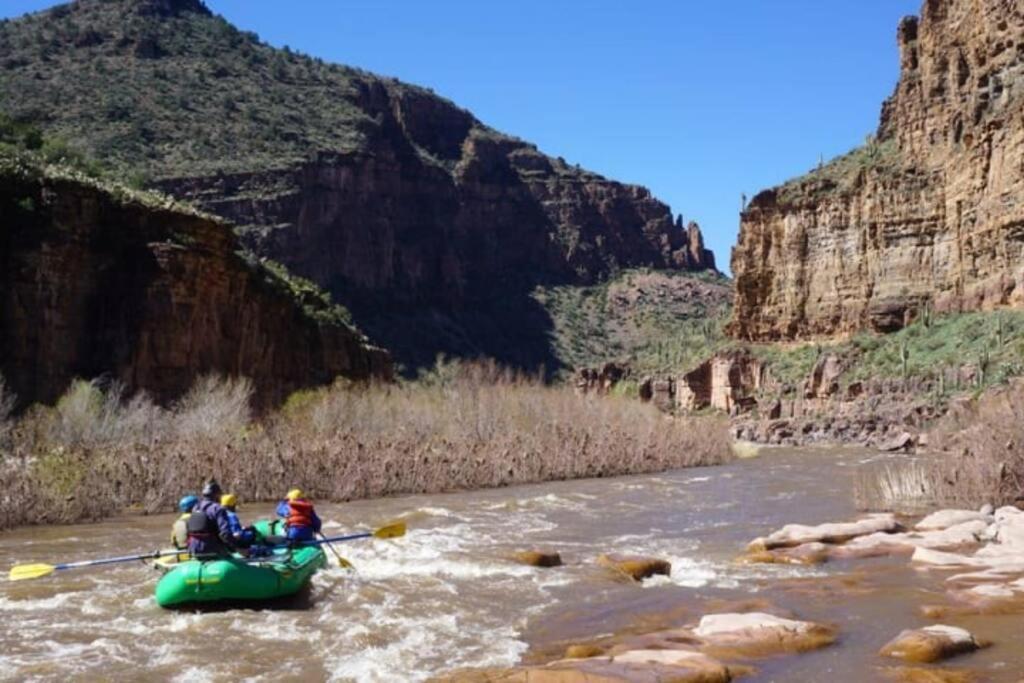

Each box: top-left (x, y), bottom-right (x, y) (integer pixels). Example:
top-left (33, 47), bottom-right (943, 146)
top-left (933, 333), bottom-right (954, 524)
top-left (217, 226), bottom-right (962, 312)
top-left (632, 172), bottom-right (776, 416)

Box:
top-left (0, 449), bottom-right (1024, 683)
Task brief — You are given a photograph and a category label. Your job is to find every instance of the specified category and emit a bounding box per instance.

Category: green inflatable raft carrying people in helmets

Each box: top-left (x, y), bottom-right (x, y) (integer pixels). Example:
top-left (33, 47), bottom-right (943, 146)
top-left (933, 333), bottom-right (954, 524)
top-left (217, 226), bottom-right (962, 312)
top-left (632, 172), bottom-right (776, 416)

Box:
top-left (157, 521), bottom-right (327, 607)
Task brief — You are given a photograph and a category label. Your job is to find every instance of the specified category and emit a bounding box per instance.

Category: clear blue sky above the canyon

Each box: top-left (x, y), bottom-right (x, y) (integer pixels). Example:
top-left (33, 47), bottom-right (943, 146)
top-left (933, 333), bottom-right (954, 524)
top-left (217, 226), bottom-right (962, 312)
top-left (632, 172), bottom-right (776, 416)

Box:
top-left (0, 0), bottom-right (922, 268)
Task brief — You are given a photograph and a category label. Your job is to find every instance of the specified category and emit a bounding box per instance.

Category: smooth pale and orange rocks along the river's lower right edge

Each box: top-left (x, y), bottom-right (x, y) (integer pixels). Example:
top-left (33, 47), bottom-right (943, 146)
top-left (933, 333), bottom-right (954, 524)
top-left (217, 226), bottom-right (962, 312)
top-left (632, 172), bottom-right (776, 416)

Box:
top-left (432, 499), bottom-right (1024, 683)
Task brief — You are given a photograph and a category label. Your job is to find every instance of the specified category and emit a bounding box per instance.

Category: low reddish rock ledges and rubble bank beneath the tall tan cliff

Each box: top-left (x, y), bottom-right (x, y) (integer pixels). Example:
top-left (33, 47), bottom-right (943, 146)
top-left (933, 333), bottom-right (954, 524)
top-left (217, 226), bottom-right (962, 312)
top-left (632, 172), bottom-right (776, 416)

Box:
top-left (575, 349), bottom-right (954, 452)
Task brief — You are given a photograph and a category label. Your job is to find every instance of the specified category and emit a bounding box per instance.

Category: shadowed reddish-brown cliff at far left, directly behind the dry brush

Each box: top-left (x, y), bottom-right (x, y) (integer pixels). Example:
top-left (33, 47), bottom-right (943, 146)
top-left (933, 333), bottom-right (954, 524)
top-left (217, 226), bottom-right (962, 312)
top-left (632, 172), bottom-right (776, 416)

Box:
top-left (0, 159), bottom-right (391, 407)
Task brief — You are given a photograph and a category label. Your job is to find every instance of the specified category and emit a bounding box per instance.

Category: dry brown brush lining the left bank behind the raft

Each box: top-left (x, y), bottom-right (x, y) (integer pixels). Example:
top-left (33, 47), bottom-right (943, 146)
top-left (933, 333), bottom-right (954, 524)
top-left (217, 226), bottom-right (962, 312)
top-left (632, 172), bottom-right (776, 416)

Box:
top-left (0, 365), bottom-right (731, 527)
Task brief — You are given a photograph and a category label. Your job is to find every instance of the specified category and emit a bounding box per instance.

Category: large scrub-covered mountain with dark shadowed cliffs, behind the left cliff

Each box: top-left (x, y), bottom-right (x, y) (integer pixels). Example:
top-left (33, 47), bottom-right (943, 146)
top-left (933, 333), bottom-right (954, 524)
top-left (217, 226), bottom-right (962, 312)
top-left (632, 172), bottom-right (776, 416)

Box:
top-left (0, 0), bottom-right (714, 368)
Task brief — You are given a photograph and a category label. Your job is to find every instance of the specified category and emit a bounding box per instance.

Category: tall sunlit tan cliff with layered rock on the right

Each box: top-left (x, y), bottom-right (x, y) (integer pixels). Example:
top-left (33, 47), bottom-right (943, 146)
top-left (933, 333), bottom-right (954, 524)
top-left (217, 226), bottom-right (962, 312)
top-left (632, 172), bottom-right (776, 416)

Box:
top-left (730, 0), bottom-right (1024, 340)
